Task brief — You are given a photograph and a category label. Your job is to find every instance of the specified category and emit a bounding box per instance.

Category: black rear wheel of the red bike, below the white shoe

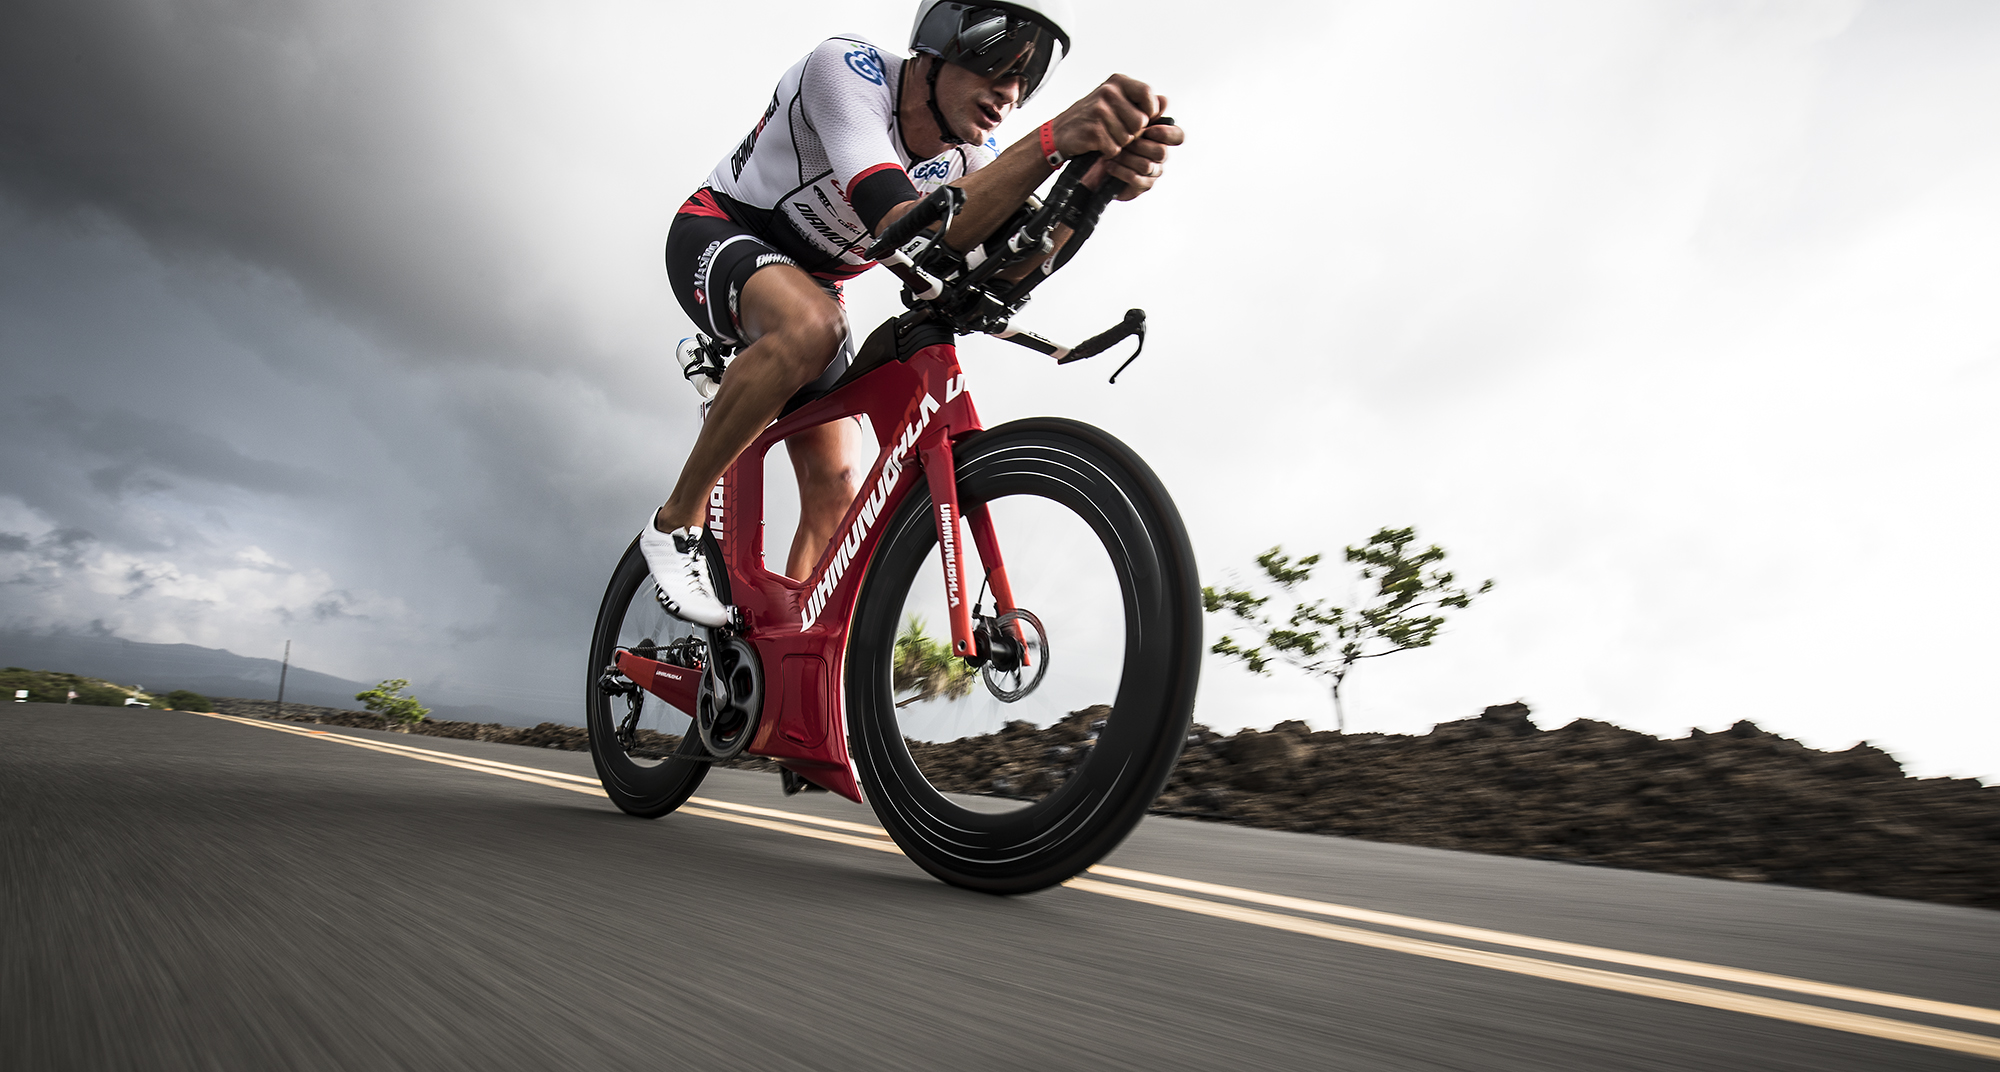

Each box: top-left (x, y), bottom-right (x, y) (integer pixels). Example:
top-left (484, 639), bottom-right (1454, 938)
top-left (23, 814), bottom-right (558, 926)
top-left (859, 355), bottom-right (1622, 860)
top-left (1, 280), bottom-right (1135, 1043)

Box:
top-left (584, 540), bottom-right (710, 818)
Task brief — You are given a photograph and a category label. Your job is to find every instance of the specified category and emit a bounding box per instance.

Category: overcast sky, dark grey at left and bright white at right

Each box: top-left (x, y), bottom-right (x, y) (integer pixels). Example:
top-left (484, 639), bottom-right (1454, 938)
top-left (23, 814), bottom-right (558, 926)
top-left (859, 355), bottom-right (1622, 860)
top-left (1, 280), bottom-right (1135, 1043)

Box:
top-left (0, 0), bottom-right (2000, 780)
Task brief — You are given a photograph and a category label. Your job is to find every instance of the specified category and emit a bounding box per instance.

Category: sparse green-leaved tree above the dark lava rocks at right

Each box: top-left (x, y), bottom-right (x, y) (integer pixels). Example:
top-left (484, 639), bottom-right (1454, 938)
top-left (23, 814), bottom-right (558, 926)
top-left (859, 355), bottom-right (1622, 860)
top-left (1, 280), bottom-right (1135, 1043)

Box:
top-left (1202, 528), bottom-right (1494, 732)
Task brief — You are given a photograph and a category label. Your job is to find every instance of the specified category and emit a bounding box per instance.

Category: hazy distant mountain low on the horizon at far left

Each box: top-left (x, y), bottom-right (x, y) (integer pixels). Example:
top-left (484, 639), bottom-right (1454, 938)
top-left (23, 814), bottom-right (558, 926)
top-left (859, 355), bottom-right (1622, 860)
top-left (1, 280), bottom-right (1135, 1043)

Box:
top-left (0, 630), bottom-right (542, 726)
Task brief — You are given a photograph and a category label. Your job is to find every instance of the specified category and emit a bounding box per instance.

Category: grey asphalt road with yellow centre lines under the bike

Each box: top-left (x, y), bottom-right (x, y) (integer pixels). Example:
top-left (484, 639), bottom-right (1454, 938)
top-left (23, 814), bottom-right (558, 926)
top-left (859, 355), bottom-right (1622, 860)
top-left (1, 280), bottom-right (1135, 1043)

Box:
top-left (11, 704), bottom-right (2000, 1072)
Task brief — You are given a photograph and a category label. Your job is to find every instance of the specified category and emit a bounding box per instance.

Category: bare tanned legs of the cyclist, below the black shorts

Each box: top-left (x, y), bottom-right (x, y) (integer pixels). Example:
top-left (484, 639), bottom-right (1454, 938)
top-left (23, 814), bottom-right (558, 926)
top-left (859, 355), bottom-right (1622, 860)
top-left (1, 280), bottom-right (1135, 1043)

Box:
top-left (654, 264), bottom-right (854, 560)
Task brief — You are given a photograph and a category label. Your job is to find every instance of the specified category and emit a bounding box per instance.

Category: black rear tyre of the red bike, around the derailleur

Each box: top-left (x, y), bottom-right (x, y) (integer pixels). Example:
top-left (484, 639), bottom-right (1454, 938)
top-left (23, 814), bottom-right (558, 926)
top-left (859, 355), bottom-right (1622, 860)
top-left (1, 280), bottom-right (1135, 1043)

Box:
top-left (584, 538), bottom-right (710, 818)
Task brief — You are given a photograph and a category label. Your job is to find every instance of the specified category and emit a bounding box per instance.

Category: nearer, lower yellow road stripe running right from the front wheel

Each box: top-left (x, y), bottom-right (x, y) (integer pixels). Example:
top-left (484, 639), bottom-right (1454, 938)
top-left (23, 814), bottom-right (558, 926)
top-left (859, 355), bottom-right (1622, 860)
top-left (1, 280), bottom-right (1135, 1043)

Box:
top-left (1068, 878), bottom-right (2000, 1058)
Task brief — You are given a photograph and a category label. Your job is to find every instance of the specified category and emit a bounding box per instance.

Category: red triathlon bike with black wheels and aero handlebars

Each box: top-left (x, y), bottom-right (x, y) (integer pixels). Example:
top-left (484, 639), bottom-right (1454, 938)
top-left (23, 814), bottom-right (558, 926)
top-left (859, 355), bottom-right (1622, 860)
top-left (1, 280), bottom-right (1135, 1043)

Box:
top-left (588, 147), bottom-right (1202, 894)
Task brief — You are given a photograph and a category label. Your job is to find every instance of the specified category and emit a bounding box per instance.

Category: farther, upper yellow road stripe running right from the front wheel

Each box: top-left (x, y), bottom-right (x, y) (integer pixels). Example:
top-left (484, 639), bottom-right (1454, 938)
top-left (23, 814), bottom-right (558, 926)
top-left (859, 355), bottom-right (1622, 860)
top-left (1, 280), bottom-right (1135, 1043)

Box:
top-left (1090, 864), bottom-right (2000, 1024)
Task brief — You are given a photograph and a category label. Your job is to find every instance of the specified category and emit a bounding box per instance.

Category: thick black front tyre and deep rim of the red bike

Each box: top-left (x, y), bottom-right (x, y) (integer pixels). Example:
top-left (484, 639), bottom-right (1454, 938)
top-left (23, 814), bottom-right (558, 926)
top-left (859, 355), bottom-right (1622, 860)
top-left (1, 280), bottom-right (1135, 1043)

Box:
top-left (846, 418), bottom-right (1202, 894)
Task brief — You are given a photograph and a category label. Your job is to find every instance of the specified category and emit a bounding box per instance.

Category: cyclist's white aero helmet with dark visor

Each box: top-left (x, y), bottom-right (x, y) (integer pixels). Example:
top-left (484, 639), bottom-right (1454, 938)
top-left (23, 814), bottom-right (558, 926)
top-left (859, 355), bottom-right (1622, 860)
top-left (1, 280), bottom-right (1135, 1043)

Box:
top-left (910, 0), bottom-right (1070, 102)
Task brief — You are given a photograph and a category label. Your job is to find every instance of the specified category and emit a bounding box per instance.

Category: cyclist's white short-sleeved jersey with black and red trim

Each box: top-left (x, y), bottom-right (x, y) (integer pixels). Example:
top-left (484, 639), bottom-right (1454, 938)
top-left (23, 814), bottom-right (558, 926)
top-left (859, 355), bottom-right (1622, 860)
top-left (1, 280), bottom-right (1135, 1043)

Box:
top-left (680, 36), bottom-right (998, 280)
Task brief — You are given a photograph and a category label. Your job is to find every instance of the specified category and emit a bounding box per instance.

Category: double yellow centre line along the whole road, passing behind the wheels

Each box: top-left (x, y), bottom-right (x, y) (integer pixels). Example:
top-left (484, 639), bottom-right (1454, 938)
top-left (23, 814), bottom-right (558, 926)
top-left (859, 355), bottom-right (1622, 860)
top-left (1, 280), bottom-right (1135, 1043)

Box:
top-left (199, 714), bottom-right (2000, 1060)
